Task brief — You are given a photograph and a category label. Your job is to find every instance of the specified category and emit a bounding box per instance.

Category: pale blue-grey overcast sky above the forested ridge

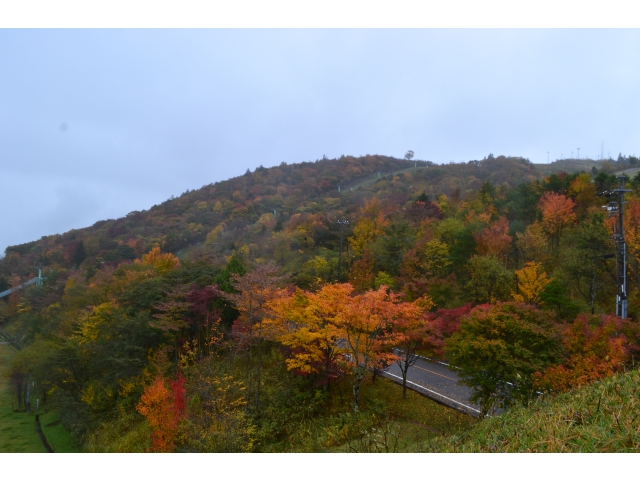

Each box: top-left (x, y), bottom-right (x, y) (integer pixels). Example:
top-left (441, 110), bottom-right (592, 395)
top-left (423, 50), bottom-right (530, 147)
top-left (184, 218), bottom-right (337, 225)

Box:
top-left (0, 29), bottom-right (640, 255)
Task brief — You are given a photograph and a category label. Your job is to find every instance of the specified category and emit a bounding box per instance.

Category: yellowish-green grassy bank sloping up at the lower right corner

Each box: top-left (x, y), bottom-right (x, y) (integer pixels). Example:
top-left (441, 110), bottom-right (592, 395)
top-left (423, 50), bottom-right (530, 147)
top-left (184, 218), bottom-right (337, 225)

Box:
top-left (429, 370), bottom-right (640, 452)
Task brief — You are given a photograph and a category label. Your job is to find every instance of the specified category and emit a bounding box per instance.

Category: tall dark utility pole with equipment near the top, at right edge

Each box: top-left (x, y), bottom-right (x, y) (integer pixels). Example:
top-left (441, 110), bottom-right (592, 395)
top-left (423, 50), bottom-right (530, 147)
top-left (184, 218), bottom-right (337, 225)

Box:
top-left (599, 174), bottom-right (632, 318)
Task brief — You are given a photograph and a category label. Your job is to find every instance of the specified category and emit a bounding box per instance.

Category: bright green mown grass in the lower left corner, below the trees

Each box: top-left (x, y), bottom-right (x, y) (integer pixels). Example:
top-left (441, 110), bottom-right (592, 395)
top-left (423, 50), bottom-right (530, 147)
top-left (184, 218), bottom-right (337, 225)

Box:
top-left (0, 344), bottom-right (78, 453)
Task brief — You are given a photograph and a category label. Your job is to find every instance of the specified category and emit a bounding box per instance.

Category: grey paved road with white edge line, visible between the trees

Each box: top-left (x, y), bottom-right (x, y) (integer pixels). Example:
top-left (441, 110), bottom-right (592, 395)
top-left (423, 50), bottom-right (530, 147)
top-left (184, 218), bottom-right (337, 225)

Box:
top-left (383, 358), bottom-right (480, 416)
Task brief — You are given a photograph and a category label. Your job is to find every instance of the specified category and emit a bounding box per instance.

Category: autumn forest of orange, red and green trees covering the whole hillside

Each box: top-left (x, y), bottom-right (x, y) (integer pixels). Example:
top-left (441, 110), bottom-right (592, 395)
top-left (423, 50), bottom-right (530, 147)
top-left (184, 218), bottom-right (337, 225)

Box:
top-left (0, 155), bottom-right (640, 451)
